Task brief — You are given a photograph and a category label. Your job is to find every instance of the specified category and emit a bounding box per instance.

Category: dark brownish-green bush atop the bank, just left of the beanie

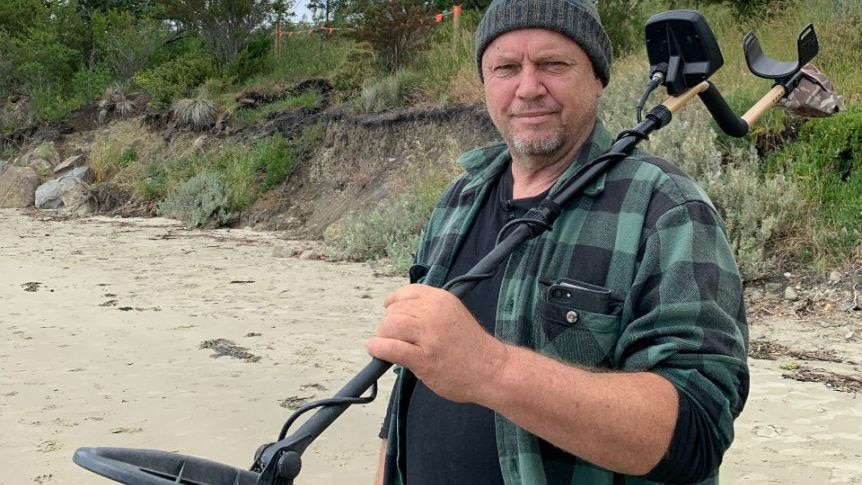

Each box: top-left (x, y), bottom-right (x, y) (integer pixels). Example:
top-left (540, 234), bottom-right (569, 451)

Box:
top-left (348, 0), bottom-right (434, 72)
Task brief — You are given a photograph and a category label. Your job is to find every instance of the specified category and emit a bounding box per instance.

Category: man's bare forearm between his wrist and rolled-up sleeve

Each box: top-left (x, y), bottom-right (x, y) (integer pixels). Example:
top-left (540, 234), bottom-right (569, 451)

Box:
top-left (477, 346), bottom-right (678, 475)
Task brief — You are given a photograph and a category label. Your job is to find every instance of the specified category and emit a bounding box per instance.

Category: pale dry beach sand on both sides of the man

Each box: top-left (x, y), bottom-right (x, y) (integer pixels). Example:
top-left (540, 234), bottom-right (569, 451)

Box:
top-left (0, 210), bottom-right (862, 485)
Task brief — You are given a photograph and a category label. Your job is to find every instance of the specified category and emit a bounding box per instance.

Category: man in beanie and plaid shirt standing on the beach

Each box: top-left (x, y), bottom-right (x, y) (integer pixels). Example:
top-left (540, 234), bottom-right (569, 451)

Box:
top-left (366, 0), bottom-right (749, 485)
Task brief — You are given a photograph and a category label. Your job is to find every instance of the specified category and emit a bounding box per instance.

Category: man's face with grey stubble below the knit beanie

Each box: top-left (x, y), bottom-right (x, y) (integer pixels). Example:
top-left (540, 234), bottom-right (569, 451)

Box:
top-left (482, 29), bottom-right (602, 158)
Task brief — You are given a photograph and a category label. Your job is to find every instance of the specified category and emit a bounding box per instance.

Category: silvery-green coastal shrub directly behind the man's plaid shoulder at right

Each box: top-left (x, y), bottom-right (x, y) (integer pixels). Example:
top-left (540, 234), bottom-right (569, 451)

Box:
top-left (600, 63), bottom-right (807, 280)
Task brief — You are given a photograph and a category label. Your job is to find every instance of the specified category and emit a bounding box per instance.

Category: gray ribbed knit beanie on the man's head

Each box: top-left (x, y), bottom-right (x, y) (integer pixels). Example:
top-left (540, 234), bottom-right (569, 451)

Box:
top-left (476, 0), bottom-right (613, 86)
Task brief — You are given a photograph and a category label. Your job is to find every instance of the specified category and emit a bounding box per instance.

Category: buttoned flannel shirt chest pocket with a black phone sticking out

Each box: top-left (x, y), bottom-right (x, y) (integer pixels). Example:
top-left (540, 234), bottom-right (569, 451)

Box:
top-left (539, 280), bottom-right (622, 368)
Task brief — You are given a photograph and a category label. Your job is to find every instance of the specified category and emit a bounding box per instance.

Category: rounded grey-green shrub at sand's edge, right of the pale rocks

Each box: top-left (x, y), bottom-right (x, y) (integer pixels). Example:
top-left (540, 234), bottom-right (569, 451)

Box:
top-left (156, 172), bottom-right (230, 227)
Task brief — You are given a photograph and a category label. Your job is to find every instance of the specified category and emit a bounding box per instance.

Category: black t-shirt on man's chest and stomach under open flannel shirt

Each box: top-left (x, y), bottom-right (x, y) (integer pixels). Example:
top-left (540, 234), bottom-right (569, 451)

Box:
top-left (382, 170), bottom-right (545, 485)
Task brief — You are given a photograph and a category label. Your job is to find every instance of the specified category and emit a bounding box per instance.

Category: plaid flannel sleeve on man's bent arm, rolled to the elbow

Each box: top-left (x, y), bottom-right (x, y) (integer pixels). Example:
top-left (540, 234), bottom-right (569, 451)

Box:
top-left (615, 201), bottom-right (749, 483)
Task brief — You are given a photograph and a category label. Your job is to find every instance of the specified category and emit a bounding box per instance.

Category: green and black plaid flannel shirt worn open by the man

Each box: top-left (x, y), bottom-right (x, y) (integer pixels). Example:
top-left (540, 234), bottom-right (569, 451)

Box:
top-left (385, 124), bottom-right (749, 485)
